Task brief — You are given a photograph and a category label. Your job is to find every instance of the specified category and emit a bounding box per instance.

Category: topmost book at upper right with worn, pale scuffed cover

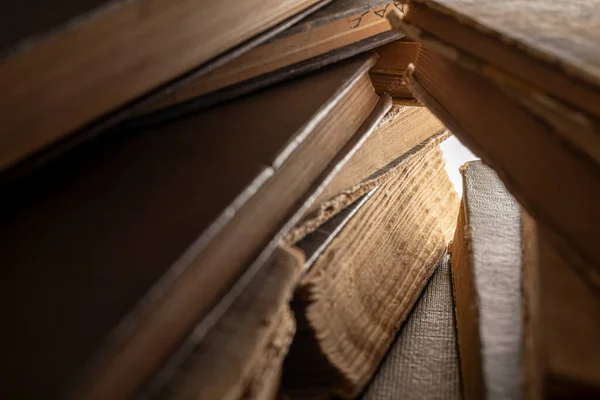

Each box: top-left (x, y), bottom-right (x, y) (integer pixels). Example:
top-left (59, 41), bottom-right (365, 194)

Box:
top-left (391, 0), bottom-right (600, 167)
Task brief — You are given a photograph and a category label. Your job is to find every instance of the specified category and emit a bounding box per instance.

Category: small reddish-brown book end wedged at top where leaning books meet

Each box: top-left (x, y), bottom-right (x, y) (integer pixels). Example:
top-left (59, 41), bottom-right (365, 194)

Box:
top-left (369, 39), bottom-right (420, 100)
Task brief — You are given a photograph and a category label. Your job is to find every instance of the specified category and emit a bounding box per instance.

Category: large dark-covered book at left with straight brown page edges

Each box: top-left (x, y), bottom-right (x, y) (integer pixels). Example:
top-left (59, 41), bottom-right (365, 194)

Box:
top-left (0, 55), bottom-right (389, 398)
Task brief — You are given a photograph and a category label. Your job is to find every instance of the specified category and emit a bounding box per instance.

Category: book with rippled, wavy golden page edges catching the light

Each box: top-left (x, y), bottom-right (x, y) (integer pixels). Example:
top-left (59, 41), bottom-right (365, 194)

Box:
top-left (283, 141), bottom-right (458, 398)
